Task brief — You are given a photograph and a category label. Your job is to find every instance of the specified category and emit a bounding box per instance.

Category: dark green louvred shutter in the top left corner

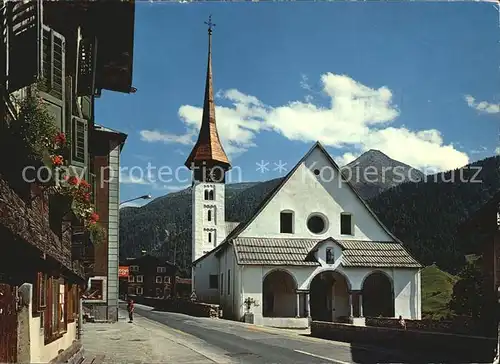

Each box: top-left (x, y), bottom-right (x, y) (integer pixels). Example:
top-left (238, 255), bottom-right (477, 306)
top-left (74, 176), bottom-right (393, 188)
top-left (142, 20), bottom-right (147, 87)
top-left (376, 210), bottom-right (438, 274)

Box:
top-left (5, 0), bottom-right (42, 92)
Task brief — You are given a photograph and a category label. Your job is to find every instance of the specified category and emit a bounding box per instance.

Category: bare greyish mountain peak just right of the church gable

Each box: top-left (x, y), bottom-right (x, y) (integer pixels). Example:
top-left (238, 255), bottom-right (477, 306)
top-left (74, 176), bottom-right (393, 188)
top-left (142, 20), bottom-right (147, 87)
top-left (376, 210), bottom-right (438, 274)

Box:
top-left (342, 149), bottom-right (425, 200)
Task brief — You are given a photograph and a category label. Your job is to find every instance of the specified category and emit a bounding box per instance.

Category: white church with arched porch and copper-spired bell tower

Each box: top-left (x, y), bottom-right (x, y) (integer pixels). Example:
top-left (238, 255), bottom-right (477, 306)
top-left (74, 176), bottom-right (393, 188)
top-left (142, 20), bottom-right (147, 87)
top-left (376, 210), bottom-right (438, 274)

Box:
top-left (186, 21), bottom-right (422, 328)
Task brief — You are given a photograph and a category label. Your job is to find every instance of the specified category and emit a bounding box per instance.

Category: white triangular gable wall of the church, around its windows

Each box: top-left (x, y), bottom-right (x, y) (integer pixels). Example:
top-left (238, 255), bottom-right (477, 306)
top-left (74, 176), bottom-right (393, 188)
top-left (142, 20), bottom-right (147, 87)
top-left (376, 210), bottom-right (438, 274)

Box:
top-left (240, 148), bottom-right (393, 241)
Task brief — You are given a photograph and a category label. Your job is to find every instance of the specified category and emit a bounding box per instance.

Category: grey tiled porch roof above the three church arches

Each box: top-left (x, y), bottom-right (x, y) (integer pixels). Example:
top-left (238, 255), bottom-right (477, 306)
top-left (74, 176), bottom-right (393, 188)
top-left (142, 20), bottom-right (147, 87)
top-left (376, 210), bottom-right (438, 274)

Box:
top-left (233, 238), bottom-right (421, 268)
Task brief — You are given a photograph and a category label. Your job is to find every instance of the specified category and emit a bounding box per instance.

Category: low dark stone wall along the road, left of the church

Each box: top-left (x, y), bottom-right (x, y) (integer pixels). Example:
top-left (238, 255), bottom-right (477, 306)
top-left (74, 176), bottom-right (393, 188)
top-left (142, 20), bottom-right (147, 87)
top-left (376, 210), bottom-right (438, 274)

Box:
top-left (128, 295), bottom-right (222, 318)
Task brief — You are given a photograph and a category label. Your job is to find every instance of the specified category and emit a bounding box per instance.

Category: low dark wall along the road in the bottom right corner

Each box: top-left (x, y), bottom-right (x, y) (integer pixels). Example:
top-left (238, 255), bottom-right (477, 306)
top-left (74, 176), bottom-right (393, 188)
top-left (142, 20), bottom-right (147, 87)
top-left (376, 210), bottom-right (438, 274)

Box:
top-left (311, 321), bottom-right (496, 363)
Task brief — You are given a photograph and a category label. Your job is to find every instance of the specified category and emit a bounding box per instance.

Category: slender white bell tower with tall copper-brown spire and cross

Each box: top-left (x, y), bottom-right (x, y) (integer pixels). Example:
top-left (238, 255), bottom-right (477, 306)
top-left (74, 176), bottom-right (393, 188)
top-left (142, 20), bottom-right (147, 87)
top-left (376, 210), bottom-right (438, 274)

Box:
top-left (185, 16), bottom-right (231, 268)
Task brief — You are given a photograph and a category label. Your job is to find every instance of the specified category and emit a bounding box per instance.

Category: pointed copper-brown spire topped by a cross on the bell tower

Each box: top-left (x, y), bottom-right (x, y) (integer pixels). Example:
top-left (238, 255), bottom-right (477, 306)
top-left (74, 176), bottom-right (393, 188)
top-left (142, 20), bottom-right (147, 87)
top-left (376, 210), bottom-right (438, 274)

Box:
top-left (185, 15), bottom-right (231, 179)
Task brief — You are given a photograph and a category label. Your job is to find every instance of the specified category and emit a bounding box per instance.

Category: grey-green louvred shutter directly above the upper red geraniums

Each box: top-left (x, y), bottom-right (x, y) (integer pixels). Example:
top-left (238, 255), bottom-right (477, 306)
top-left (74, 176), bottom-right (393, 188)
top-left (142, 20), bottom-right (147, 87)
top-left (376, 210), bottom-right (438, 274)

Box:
top-left (40, 25), bottom-right (67, 131)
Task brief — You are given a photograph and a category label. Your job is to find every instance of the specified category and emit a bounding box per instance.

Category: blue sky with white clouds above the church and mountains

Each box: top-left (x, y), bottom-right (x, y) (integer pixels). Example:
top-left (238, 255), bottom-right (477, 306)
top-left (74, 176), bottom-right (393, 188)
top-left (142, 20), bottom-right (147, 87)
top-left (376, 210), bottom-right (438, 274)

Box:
top-left (96, 2), bottom-right (500, 206)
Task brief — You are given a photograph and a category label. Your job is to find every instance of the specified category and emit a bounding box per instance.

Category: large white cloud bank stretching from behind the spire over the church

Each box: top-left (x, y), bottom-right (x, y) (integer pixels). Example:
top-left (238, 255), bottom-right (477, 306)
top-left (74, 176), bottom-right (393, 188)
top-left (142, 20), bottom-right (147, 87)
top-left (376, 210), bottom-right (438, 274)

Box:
top-left (141, 73), bottom-right (469, 171)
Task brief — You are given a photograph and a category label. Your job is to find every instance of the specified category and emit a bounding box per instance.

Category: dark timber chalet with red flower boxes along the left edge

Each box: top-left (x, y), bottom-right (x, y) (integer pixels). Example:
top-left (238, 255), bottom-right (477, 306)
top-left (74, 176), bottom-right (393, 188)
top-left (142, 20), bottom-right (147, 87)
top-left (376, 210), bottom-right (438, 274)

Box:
top-left (0, 0), bottom-right (135, 363)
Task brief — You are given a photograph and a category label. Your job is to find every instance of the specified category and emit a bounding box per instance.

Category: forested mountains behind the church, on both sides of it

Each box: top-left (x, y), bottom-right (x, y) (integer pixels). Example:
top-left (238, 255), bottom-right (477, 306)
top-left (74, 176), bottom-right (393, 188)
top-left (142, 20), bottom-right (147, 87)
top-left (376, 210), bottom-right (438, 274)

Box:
top-left (120, 150), bottom-right (500, 274)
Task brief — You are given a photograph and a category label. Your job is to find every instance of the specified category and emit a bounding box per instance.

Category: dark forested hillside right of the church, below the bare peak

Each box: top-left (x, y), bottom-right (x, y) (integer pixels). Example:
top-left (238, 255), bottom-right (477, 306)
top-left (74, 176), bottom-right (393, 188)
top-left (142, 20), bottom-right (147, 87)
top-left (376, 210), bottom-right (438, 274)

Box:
top-left (369, 156), bottom-right (500, 273)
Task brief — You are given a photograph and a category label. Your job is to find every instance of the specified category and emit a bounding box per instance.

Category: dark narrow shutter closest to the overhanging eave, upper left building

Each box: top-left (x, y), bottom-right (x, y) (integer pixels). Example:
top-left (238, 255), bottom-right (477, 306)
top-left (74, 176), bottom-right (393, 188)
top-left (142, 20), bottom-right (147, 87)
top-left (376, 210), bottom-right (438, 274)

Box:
top-left (76, 37), bottom-right (97, 96)
